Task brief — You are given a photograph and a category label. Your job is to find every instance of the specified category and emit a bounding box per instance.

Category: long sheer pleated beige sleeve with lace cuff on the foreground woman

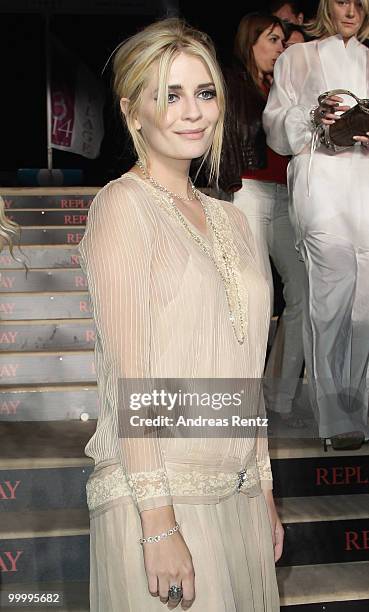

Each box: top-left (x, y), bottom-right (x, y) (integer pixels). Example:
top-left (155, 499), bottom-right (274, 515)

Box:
top-left (79, 180), bottom-right (172, 511)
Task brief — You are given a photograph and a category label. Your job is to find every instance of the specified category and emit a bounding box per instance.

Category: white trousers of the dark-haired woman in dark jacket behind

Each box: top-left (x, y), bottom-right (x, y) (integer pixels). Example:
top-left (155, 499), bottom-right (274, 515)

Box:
top-left (233, 179), bottom-right (306, 413)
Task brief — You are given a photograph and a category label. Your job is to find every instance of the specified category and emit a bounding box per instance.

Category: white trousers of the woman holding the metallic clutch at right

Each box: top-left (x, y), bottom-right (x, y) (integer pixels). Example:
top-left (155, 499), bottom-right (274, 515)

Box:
top-left (288, 148), bottom-right (369, 438)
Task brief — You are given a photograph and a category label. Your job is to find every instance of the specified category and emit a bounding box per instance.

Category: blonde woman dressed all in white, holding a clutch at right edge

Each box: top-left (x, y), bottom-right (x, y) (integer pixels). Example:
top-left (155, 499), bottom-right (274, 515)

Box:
top-left (264, 0), bottom-right (369, 450)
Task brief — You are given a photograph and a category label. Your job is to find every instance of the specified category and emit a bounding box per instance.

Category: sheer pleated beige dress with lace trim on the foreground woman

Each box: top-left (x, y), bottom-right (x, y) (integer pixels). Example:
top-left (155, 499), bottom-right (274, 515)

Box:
top-left (79, 173), bottom-right (279, 612)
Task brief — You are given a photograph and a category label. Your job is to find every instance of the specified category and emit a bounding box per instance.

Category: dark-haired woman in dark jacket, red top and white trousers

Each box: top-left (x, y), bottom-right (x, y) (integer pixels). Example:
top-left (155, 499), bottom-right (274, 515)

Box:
top-left (219, 13), bottom-right (305, 427)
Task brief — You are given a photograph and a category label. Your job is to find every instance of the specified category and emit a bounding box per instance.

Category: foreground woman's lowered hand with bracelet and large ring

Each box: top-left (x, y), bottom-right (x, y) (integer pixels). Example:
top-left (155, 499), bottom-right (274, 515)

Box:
top-left (141, 506), bottom-right (195, 610)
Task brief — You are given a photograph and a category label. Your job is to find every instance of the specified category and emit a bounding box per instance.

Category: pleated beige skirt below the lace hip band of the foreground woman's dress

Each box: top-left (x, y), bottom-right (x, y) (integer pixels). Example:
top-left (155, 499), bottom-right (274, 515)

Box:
top-left (90, 464), bottom-right (280, 612)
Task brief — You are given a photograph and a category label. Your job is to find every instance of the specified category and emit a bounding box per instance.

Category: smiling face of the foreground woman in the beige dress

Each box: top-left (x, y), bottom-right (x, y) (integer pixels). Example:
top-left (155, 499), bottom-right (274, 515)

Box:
top-left (135, 52), bottom-right (219, 165)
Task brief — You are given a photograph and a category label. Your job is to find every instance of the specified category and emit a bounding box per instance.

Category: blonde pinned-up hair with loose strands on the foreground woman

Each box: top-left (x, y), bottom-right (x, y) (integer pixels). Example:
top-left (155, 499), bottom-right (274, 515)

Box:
top-left (113, 18), bottom-right (225, 180)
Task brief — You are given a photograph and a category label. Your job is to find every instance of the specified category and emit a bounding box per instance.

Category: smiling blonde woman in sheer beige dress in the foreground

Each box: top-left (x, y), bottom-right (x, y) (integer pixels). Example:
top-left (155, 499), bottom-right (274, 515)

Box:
top-left (79, 19), bottom-right (283, 612)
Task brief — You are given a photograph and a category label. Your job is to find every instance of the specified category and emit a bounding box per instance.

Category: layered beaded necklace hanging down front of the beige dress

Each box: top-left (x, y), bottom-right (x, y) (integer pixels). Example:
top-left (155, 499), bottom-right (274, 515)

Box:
top-left (136, 160), bottom-right (248, 344)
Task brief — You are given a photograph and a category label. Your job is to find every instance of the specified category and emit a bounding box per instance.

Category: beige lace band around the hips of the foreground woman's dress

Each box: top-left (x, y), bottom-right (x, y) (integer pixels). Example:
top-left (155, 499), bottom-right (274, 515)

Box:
top-left (86, 465), bottom-right (260, 511)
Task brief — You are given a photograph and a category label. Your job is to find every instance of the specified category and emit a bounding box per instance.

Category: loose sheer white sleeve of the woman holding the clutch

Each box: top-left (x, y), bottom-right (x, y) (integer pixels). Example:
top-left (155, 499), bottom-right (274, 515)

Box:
top-left (263, 48), bottom-right (313, 155)
